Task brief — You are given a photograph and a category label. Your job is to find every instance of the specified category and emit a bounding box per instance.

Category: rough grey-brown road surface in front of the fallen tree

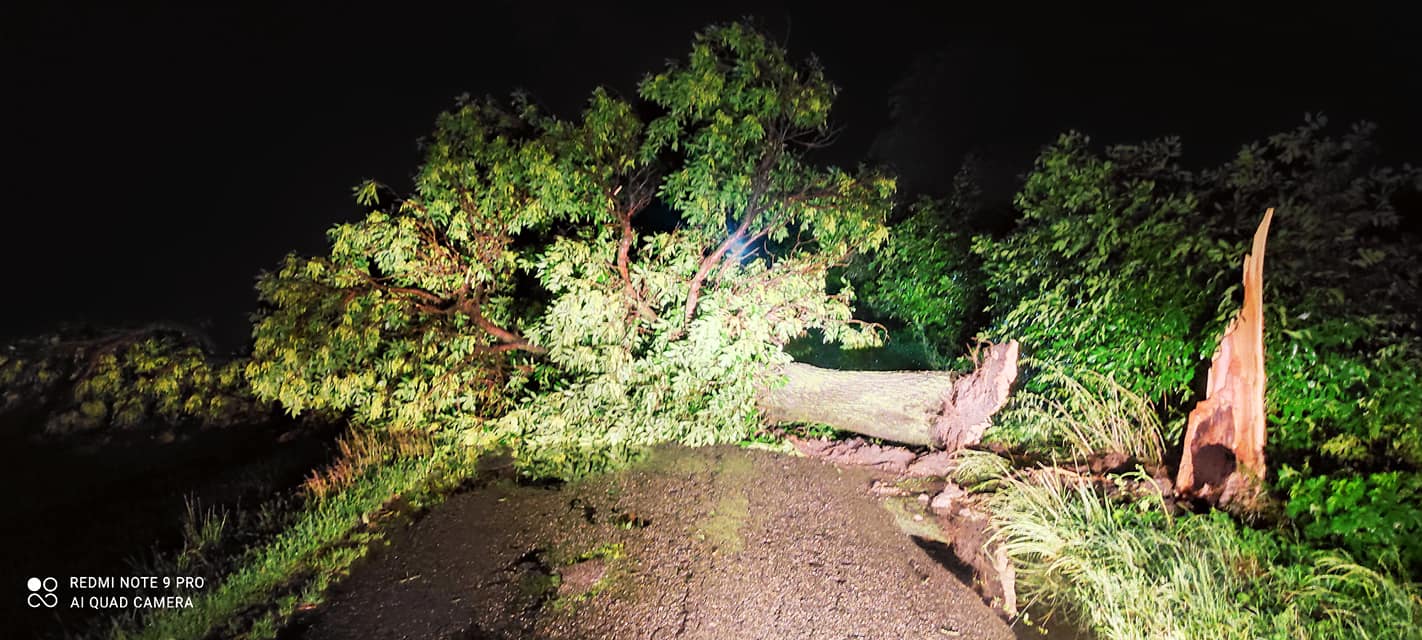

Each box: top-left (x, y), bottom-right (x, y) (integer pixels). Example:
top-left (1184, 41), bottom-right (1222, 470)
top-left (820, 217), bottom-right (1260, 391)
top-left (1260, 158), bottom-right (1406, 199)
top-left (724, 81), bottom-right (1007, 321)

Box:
top-left (289, 447), bottom-right (1035, 640)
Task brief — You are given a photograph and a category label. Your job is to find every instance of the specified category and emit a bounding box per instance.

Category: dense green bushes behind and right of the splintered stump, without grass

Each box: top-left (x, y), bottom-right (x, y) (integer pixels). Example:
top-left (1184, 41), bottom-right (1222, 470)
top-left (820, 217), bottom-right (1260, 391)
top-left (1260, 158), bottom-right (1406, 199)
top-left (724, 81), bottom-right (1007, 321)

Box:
top-left (865, 118), bottom-right (1422, 567)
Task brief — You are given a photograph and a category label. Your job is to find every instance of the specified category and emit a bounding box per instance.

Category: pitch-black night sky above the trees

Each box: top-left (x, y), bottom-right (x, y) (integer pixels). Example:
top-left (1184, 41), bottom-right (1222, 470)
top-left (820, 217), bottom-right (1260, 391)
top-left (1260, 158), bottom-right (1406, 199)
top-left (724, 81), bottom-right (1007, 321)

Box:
top-left (0, 1), bottom-right (1422, 347)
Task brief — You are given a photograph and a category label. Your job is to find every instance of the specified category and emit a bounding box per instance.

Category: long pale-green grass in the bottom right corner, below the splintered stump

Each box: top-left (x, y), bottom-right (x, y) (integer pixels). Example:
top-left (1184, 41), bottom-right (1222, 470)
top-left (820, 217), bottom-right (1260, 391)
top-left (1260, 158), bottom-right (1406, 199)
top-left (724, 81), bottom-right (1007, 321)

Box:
top-left (991, 469), bottom-right (1422, 640)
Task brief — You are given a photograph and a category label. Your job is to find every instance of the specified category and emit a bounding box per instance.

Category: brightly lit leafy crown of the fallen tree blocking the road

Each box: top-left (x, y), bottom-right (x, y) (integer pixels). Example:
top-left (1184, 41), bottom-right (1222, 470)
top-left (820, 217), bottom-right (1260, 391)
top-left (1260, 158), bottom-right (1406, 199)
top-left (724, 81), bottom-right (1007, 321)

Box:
top-left (247, 24), bottom-right (893, 475)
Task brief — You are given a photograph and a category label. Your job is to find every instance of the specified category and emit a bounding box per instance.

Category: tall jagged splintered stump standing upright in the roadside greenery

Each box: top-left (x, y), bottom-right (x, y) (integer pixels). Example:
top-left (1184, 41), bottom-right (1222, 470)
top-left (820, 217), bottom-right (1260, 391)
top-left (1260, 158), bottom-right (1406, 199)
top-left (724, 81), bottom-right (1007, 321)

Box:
top-left (1176, 209), bottom-right (1274, 512)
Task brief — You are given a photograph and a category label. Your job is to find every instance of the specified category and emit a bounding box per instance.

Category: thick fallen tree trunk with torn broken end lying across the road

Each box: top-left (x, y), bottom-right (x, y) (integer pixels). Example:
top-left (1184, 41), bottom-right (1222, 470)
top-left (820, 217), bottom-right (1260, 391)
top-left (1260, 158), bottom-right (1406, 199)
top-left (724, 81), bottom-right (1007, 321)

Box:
top-left (757, 341), bottom-right (1017, 451)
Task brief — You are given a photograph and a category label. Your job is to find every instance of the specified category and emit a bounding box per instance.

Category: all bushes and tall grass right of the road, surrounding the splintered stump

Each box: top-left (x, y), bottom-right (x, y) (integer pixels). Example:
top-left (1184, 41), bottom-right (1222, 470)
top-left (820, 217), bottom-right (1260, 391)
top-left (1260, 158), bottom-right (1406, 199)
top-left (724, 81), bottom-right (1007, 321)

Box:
top-left (863, 117), bottom-right (1422, 639)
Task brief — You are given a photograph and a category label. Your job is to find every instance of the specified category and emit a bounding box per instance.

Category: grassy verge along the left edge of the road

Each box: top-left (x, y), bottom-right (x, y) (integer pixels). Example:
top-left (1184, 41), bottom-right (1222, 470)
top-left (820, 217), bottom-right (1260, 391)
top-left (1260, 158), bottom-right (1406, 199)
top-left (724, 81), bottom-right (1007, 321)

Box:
top-left (94, 435), bottom-right (476, 639)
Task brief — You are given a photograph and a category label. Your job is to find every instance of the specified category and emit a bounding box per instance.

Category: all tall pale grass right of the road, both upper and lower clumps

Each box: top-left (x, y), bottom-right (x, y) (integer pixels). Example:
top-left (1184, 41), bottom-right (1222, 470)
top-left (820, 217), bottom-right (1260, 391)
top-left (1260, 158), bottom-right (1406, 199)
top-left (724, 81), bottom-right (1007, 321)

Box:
top-left (990, 367), bottom-right (1422, 640)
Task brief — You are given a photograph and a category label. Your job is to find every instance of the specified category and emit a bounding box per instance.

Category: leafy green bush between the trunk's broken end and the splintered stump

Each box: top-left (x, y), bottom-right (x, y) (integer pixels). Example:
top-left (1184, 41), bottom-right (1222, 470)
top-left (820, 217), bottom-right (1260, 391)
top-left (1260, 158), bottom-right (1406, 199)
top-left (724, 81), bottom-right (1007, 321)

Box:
top-left (974, 134), bottom-right (1222, 402)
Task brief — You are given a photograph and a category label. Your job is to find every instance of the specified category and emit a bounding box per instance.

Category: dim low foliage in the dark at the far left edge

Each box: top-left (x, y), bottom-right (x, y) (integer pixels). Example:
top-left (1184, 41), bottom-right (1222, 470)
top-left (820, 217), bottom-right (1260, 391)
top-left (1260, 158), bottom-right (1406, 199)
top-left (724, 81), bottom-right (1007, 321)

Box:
top-left (0, 327), bottom-right (269, 435)
